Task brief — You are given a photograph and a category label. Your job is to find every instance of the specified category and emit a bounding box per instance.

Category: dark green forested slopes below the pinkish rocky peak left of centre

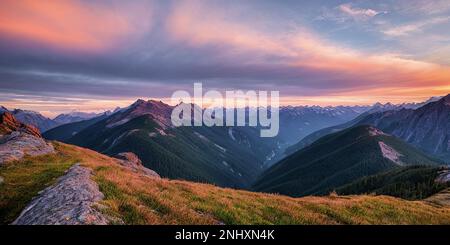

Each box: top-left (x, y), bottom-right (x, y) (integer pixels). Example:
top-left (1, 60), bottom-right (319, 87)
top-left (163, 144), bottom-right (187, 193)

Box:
top-left (67, 115), bottom-right (274, 187)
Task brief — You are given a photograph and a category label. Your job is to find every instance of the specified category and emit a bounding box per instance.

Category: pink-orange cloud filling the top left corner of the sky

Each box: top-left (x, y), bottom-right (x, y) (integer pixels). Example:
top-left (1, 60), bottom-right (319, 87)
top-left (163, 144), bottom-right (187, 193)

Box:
top-left (0, 0), bottom-right (151, 51)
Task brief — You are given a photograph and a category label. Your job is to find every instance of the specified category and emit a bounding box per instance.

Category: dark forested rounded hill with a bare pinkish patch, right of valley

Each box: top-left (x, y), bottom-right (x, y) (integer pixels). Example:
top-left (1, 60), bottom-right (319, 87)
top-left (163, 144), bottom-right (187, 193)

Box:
top-left (253, 125), bottom-right (439, 196)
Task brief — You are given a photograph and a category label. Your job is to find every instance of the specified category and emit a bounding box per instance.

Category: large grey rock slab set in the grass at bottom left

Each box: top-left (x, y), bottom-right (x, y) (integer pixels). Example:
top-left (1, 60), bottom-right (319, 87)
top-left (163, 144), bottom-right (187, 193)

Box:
top-left (12, 164), bottom-right (109, 225)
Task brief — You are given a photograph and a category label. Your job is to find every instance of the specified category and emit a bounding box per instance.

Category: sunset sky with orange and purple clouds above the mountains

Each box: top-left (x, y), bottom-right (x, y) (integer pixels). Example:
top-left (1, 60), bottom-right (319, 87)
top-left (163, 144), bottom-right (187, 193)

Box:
top-left (0, 0), bottom-right (450, 116)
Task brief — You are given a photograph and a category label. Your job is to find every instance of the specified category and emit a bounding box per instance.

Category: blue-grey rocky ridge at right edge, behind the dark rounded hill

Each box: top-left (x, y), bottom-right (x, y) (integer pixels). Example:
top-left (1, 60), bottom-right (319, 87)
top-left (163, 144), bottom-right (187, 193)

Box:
top-left (288, 95), bottom-right (450, 162)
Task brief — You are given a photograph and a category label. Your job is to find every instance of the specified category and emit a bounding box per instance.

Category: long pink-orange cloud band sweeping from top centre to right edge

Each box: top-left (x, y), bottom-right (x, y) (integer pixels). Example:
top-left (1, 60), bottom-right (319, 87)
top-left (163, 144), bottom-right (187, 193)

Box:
top-left (167, 2), bottom-right (450, 102)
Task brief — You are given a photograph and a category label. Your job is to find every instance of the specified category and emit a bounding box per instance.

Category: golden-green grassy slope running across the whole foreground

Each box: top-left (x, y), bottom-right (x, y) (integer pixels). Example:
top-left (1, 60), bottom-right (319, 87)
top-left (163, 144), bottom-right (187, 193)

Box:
top-left (0, 143), bottom-right (450, 224)
